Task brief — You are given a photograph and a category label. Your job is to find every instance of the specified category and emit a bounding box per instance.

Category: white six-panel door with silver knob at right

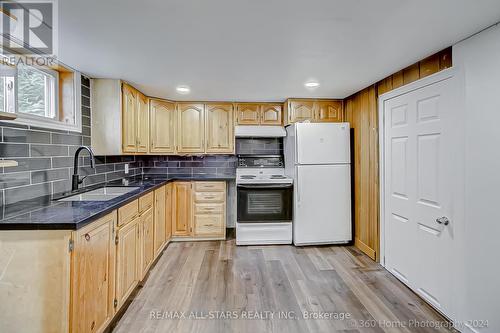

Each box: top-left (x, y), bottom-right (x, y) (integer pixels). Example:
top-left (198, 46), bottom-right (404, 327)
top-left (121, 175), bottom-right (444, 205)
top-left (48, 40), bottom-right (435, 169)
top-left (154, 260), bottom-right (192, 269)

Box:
top-left (384, 78), bottom-right (460, 315)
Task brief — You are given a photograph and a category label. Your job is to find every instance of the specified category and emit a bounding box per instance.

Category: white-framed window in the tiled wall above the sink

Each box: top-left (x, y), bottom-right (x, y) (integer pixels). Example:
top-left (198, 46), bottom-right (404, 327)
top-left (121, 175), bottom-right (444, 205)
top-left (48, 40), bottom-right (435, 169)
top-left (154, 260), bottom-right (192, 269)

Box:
top-left (0, 57), bottom-right (81, 132)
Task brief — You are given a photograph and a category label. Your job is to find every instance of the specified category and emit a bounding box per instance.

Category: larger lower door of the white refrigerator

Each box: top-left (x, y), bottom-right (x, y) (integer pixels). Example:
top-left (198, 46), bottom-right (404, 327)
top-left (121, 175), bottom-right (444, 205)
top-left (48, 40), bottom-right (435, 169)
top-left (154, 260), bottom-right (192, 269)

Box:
top-left (293, 164), bottom-right (352, 245)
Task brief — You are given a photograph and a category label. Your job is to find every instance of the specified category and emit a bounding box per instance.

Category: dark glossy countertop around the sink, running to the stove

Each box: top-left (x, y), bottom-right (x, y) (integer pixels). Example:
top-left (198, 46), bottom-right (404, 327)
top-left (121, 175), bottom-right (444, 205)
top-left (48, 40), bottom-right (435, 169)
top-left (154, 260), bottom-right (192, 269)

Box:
top-left (0, 175), bottom-right (234, 230)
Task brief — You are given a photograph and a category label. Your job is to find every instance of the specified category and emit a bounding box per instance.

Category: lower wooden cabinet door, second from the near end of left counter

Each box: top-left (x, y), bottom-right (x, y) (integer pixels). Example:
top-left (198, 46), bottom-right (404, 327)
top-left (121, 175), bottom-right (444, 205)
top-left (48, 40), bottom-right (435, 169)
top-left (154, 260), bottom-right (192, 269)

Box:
top-left (116, 218), bottom-right (140, 310)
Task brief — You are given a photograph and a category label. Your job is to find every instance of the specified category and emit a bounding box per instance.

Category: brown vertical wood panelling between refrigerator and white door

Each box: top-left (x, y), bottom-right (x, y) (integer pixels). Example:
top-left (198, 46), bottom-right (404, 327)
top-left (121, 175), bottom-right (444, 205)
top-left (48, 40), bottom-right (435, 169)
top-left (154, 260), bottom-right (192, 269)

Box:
top-left (344, 47), bottom-right (452, 261)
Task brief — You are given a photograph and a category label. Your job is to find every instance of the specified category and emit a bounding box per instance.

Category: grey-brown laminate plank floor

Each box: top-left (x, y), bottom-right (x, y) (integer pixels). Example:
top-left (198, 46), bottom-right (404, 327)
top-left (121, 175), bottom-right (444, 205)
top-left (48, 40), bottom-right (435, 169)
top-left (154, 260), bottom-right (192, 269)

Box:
top-left (113, 239), bottom-right (458, 333)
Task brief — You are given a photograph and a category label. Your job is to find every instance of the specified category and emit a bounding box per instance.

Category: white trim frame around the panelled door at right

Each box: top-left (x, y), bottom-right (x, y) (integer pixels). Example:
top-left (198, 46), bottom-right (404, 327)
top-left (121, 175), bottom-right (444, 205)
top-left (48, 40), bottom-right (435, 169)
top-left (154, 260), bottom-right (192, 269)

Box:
top-left (377, 67), bottom-right (465, 267)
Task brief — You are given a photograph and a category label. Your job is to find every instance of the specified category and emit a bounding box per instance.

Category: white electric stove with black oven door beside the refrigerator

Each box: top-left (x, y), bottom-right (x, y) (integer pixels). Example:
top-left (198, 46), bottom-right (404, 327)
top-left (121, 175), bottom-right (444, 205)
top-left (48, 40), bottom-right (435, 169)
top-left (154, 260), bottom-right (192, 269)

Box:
top-left (236, 155), bottom-right (293, 245)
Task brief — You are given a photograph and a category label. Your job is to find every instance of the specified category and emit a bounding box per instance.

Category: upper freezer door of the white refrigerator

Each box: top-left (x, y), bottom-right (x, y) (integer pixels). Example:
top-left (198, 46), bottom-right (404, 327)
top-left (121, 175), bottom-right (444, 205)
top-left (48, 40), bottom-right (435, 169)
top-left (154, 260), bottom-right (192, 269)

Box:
top-left (296, 123), bottom-right (351, 165)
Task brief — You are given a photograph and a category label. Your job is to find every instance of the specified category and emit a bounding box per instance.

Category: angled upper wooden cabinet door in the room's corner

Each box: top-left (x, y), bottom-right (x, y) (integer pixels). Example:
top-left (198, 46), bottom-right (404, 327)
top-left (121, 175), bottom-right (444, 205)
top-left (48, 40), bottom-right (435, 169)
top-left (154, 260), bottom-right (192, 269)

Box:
top-left (150, 100), bottom-right (175, 154)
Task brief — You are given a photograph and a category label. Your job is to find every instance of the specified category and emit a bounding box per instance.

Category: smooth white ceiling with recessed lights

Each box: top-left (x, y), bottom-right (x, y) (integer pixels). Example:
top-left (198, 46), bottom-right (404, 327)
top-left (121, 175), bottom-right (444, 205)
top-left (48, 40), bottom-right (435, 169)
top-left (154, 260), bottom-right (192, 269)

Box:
top-left (59, 0), bottom-right (500, 101)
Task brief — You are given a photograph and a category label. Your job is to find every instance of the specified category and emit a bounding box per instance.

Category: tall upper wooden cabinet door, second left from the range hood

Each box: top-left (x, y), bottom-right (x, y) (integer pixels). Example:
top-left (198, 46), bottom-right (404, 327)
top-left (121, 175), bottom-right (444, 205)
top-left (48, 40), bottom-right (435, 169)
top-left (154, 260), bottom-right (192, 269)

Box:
top-left (177, 103), bottom-right (205, 153)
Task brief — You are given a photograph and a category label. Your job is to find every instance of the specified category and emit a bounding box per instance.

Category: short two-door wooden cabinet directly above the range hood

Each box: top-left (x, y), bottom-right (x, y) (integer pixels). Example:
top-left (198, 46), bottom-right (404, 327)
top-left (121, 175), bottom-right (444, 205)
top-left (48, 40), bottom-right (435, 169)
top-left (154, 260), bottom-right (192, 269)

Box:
top-left (236, 103), bottom-right (283, 126)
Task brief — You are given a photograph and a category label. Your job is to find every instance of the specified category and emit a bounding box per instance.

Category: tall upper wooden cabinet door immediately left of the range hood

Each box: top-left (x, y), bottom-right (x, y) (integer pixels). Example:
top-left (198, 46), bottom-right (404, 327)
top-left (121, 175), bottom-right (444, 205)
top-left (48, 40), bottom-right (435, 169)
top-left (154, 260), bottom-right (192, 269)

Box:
top-left (205, 103), bottom-right (234, 154)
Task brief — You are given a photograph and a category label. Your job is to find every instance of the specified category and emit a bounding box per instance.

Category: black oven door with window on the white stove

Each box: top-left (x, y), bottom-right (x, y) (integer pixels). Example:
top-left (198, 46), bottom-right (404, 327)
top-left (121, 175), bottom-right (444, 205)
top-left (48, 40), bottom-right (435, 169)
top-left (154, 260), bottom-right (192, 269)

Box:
top-left (237, 184), bottom-right (293, 223)
